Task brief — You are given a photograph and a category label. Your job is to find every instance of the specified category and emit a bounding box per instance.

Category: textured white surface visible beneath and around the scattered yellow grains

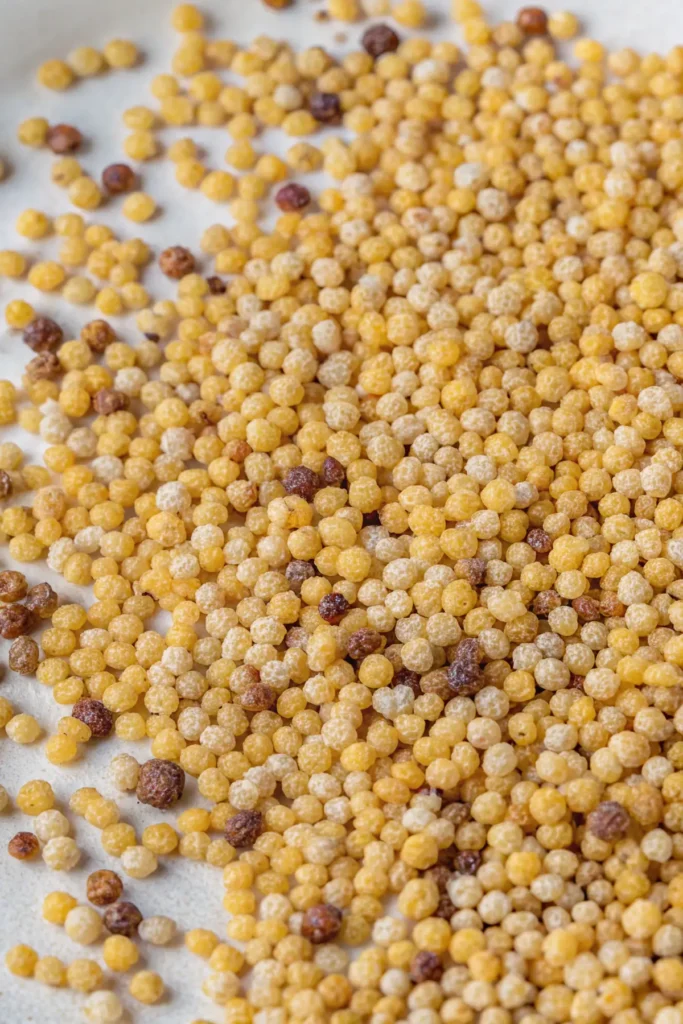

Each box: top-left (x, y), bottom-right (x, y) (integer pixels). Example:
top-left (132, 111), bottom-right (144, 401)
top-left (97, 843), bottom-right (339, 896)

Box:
top-left (0, 0), bottom-right (683, 1024)
